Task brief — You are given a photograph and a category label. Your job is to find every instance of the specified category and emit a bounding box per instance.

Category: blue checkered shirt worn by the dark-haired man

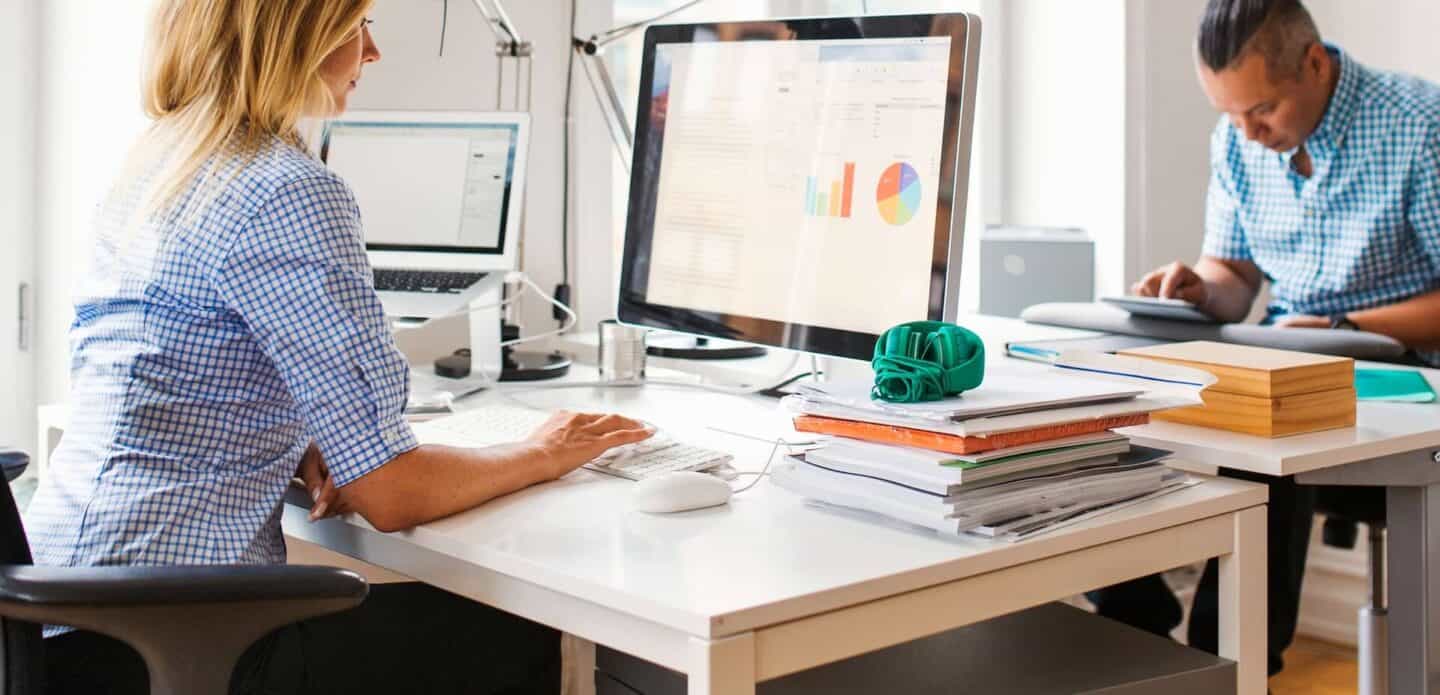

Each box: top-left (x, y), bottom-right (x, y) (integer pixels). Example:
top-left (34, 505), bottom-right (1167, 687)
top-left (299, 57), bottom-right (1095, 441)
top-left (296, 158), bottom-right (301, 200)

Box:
top-left (1204, 46), bottom-right (1440, 365)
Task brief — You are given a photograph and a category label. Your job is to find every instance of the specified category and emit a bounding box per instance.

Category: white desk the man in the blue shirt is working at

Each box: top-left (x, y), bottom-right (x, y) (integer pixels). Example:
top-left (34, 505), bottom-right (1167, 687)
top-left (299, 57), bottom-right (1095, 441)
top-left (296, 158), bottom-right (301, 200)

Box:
top-left (965, 317), bottom-right (1440, 694)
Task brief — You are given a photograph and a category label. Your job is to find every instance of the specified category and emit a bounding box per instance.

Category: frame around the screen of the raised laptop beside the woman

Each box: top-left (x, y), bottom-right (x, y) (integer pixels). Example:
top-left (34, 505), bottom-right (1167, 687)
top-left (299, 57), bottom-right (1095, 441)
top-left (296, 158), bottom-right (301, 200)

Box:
top-left (317, 109), bottom-right (531, 272)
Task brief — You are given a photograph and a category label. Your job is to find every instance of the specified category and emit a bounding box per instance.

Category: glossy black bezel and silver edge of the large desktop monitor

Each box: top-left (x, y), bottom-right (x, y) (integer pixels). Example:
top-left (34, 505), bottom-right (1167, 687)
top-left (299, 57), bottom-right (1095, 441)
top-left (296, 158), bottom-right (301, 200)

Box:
top-left (616, 13), bottom-right (981, 360)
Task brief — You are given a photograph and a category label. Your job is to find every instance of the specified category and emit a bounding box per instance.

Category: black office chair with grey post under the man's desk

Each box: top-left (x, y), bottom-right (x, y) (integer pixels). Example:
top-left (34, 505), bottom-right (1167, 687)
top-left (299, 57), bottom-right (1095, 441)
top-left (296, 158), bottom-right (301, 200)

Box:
top-left (1315, 485), bottom-right (1390, 695)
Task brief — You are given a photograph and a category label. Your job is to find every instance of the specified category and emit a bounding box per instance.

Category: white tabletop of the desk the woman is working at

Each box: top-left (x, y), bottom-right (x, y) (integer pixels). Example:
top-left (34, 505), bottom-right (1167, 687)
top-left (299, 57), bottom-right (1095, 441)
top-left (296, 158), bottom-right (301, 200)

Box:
top-left (298, 389), bottom-right (1264, 637)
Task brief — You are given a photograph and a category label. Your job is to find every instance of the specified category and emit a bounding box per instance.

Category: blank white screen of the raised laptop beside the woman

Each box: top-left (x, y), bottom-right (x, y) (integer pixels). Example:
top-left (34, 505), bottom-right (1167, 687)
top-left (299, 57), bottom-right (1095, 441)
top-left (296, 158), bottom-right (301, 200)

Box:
top-left (321, 119), bottom-right (520, 253)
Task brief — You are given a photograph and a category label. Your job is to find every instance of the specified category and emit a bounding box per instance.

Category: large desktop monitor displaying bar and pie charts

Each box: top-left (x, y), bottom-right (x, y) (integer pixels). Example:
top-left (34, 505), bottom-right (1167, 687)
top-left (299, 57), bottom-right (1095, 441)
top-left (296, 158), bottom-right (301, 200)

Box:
top-left (618, 14), bottom-right (981, 360)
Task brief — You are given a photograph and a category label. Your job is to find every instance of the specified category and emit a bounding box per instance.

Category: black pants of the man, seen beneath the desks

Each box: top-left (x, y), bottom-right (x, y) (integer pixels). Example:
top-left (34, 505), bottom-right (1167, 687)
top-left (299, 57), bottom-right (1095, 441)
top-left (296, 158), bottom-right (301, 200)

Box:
top-left (1089, 471), bottom-right (1315, 675)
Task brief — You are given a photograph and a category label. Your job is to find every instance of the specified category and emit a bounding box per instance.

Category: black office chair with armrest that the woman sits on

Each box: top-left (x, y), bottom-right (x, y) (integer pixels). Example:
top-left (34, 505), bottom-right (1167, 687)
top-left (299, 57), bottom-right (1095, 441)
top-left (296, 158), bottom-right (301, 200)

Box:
top-left (0, 450), bottom-right (369, 695)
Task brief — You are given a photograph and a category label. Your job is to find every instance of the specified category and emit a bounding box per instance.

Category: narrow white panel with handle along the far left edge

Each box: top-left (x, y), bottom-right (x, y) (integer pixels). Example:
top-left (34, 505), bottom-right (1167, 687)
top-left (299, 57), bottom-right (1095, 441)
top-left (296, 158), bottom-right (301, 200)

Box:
top-left (0, 0), bottom-right (39, 450)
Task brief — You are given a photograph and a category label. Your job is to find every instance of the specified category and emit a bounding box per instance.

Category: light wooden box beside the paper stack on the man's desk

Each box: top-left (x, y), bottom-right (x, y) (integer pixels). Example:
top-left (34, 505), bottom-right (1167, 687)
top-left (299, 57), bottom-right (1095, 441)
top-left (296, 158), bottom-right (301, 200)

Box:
top-left (1120, 341), bottom-right (1355, 437)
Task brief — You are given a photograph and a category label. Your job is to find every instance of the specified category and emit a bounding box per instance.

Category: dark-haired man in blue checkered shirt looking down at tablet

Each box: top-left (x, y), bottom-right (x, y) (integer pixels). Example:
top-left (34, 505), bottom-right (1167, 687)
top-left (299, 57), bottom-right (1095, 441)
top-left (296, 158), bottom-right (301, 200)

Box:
top-left (1094, 0), bottom-right (1440, 673)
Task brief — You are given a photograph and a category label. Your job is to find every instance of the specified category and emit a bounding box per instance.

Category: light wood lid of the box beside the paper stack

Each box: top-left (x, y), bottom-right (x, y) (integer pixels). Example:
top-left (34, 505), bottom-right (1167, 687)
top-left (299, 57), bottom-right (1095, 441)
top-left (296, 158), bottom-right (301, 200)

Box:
top-left (1119, 341), bottom-right (1355, 399)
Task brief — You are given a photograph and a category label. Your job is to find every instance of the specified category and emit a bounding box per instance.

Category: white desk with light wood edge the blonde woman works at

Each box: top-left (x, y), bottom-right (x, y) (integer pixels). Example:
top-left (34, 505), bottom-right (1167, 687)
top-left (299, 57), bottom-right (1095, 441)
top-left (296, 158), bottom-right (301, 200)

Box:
top-left (33, 356), bottom-right (1266, 695)
